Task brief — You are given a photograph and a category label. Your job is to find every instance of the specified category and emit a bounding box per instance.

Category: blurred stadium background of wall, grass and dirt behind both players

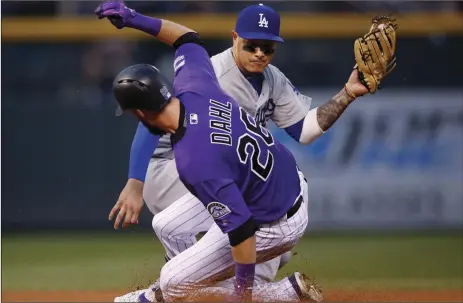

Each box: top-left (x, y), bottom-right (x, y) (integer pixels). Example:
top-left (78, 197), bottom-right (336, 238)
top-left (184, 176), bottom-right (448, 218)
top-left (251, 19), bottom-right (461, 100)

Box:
top-left (1, 1), bottom-right (463, 301)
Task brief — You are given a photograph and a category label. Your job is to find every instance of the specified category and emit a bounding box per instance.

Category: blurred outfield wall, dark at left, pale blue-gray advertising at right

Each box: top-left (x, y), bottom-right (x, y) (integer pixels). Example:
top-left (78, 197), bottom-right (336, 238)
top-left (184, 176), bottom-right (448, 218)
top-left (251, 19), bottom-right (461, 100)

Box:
top-left (2, 89), bottom-right (463, 229)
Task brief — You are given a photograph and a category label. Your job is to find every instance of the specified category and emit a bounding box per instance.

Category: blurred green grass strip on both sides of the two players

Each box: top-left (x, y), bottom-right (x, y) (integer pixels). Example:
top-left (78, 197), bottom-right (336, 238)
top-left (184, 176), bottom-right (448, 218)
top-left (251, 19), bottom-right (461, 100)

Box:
top-left (2, 232), bottom-right (463, 290)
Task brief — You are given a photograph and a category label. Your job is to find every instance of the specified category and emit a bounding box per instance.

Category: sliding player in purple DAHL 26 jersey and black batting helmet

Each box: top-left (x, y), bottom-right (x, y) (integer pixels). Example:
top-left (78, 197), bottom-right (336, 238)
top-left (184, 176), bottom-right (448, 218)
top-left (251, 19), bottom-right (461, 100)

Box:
top-left (97, 3), bottom-right (321, 302)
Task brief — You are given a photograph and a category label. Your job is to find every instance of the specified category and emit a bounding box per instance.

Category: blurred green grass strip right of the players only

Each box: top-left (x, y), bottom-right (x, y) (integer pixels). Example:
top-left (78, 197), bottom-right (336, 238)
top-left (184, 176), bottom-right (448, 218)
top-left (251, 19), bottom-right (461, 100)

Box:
top-left (284, 235), bottom-right (463, 288)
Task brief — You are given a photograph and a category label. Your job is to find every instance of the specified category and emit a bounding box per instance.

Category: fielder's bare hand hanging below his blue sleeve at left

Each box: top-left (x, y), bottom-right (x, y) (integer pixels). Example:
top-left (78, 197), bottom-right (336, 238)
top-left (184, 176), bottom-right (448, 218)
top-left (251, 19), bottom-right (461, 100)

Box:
top-left (109, 179), bottom-right (143, 229)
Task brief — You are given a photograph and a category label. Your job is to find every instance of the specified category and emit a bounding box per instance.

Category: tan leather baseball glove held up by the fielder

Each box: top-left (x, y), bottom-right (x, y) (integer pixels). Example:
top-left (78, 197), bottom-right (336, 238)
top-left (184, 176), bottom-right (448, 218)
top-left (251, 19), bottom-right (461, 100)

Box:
top-left (354, 16), bottom-right (398, 94)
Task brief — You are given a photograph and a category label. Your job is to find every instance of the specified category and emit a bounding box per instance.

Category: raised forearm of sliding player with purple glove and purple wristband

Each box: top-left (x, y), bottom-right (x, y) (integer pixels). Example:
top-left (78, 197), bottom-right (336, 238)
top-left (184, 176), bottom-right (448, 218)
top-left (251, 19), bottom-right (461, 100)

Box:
top-left (95, 0), bottom-right (195, 46)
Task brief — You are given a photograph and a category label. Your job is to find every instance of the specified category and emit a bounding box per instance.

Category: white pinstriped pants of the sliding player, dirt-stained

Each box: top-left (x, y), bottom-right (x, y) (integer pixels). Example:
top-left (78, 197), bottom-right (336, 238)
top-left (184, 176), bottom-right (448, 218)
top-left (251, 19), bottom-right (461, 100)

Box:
top-left (158, 173), bottom-right (308, 302)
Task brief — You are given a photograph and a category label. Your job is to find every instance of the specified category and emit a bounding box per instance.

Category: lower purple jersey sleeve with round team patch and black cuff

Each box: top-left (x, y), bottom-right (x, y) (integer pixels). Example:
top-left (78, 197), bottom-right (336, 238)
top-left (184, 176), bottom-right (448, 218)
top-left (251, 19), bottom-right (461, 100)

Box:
top-left (191, 179), bottom-right (251, 233)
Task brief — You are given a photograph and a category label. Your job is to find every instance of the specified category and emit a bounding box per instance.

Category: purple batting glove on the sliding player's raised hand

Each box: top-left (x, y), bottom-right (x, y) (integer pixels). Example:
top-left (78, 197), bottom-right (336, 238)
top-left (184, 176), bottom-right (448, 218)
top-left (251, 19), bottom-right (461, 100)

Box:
top-left (95, 0), bottom-right (136, 29)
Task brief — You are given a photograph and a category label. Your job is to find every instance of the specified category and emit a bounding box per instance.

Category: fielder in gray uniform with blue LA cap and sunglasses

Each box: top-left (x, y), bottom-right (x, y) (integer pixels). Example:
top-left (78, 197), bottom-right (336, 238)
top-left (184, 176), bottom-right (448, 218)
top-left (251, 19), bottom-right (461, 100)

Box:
top-left (101, 4), bottom-right (366, 301)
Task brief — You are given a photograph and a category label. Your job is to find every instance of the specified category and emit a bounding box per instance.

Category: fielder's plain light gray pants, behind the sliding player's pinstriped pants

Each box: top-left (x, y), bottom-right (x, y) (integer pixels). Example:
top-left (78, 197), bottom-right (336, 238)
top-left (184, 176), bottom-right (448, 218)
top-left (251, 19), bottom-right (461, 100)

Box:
top-left (143, 159), bottom-right (291, 283)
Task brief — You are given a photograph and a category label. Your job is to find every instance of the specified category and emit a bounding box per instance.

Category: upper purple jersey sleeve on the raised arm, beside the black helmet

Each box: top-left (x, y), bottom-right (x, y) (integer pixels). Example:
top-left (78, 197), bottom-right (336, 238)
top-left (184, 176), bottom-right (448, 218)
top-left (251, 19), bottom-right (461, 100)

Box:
top-left (174, 43), bottom-right (220, 96)
